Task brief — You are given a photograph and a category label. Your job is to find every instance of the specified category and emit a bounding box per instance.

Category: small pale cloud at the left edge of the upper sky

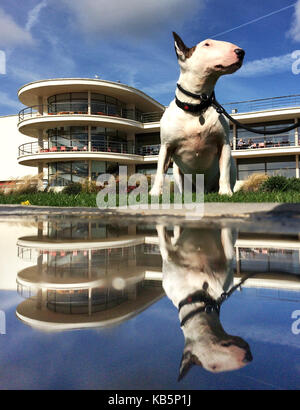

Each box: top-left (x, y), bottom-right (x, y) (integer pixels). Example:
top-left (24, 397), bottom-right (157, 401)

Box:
top-left (0, 8), bottom-right (34, 48)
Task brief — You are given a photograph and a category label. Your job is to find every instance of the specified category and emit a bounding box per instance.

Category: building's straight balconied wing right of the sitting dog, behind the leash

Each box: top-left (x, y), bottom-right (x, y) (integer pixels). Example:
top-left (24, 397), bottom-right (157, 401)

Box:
top-left (225, 95), bottom-right (300, 180)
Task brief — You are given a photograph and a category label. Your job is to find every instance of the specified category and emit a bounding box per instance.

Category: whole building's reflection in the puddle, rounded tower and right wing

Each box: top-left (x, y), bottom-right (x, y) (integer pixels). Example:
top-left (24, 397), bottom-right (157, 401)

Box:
top-left (17, 219), bottom-right (300, 330)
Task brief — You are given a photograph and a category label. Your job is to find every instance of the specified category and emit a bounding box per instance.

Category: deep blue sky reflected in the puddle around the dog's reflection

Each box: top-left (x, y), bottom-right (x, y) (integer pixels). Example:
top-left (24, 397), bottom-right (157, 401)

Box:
top-left (0, 288), bottom-right (300, 389)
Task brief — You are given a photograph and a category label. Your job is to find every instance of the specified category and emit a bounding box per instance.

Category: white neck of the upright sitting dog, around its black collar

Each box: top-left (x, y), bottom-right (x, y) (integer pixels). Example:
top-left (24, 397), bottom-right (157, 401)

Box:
top-left (176, 72), bottom-right (218, 103)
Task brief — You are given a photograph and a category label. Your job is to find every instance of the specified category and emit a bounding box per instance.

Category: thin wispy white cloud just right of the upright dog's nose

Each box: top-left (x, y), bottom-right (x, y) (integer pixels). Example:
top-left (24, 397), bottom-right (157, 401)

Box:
top-left (235, 53), bottom-right (295, 77)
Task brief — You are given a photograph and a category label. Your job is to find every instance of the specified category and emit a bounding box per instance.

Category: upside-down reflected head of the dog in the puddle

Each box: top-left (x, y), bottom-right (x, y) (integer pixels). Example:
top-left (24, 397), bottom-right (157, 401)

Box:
top-left (178, 335), bottom-right (252, 381)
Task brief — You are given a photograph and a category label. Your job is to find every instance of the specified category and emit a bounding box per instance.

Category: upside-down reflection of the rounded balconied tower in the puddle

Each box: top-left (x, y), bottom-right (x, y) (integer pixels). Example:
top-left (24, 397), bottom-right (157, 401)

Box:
top-left (17, 221), bottom-right (164, 330)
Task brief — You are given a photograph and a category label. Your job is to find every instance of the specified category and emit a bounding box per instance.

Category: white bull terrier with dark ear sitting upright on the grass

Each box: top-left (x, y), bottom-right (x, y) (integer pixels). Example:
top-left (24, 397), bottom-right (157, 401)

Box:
top-left (150, 33), bottom-right (245, 196)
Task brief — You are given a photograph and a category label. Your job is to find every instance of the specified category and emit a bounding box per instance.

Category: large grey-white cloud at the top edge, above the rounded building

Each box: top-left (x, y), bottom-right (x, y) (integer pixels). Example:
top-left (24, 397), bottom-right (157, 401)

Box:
top-left (62, 0), bottom-right (205, 38)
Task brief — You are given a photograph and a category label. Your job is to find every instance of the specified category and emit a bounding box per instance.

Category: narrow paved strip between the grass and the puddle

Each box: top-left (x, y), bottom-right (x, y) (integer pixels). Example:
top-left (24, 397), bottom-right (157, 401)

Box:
top-left (0, 202), bottom-right (300, 234)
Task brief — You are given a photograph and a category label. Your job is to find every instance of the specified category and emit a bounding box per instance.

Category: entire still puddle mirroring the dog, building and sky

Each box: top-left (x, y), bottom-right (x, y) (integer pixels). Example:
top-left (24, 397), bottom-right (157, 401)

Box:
top-left (0, 217), bottom-right (300, 390)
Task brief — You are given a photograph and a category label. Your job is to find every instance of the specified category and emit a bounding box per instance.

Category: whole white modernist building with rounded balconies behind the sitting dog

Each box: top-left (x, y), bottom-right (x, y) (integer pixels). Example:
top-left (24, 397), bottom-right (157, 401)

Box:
top-left (0, 78), bottom-right (300, 187)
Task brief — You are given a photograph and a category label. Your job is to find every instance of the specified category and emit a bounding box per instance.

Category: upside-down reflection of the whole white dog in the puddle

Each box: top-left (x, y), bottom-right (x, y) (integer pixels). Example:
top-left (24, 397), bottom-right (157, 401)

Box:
top-left (157, 225), bottom-right (252, 380)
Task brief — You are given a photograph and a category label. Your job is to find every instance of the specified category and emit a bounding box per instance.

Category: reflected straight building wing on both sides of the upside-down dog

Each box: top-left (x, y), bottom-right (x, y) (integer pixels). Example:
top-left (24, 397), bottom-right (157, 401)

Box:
top-left (137, 226), bottom-right (300, 289)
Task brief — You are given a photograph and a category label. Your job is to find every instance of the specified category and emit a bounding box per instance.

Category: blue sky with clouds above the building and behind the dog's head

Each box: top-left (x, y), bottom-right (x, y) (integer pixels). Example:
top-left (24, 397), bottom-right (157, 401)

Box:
top-left (0, 0), bottom-right (300, 115)
